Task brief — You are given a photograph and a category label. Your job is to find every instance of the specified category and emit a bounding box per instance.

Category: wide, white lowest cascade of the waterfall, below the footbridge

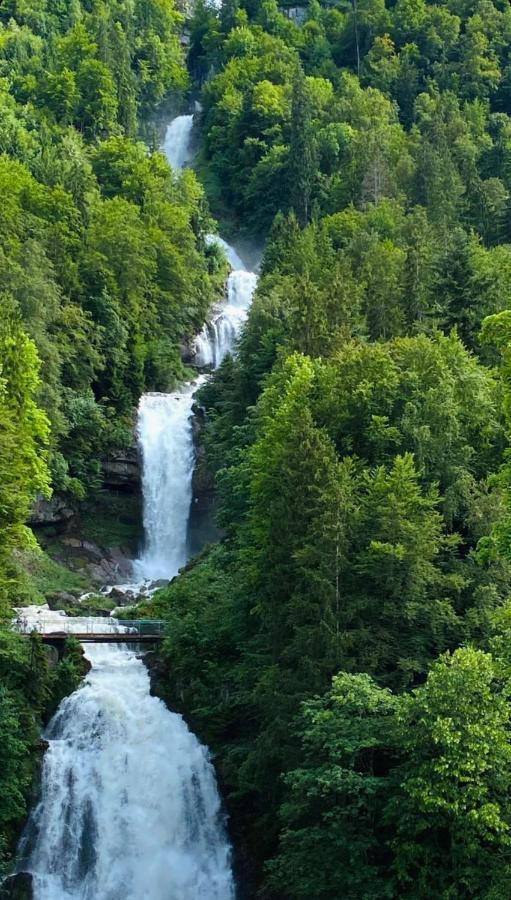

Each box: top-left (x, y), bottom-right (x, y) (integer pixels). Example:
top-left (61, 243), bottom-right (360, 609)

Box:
top-left (20, 613), bottom-right (234, 900)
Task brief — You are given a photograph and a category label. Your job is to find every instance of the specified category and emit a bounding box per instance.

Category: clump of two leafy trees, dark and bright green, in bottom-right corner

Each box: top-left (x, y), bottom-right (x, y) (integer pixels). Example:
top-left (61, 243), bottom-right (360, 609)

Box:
top-left (267, 648), bottom-right (511, 900)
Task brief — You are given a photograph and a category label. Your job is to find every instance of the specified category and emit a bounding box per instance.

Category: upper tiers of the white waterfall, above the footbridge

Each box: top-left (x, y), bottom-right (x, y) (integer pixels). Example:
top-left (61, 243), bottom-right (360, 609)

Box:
top-left (134, 116), bottom-right (257, 581)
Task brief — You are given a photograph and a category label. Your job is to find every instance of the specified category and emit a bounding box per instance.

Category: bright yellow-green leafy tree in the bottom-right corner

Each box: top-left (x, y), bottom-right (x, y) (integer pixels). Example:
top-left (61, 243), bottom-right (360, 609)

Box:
top-left (391, 649), bottom-right (511, 898)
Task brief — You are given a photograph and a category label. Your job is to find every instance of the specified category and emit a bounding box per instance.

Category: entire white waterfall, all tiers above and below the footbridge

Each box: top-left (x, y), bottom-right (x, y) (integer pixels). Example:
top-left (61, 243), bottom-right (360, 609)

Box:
top-left (14, 116), bottom-right (257, 900)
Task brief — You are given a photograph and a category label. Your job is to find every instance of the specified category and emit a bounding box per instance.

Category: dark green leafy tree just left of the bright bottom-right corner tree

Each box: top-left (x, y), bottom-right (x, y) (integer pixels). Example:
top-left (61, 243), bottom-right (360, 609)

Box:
top-left (268, 674), bottom-right (399, 900)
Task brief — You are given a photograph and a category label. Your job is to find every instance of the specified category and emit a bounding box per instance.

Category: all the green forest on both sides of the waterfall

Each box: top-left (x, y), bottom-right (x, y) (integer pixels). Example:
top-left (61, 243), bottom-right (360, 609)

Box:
top-left (5, 0), bottom-right (511, 900)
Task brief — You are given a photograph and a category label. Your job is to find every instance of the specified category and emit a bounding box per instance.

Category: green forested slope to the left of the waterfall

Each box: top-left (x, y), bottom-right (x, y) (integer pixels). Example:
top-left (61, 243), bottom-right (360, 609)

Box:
top-left (0, 0), bottom-right (225, 867)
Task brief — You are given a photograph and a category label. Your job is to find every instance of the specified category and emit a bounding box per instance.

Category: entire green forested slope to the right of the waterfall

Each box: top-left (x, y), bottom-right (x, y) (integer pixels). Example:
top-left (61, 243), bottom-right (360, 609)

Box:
top-left (149, 0), bottom-right (511, 900)
